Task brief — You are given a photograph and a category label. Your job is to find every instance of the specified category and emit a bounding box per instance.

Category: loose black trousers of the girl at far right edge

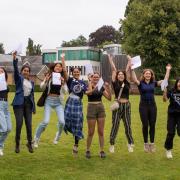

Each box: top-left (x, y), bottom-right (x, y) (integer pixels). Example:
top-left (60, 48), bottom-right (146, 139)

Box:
top-left (164, 113), bottom-right (180, 150)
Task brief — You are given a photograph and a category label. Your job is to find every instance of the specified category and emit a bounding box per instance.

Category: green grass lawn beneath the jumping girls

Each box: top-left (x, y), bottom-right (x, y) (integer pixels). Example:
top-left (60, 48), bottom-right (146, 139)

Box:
top-left (0, 93), bottom-right (180, 180)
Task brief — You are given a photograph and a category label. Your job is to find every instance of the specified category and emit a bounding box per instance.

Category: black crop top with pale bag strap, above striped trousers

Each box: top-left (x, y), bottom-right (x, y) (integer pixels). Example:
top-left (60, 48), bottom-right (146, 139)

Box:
top-left (112, 80), bottom-right (130, 99)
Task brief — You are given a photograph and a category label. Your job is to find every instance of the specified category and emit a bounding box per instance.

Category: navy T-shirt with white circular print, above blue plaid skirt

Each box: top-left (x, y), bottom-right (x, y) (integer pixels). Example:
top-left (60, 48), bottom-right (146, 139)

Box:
top-left (67, 77), bottom-right (87, 98)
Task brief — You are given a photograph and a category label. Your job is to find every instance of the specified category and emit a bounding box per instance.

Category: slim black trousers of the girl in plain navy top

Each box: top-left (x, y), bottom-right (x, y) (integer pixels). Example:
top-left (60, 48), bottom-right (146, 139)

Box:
top-left (139, 102), bottom-right (157, 143)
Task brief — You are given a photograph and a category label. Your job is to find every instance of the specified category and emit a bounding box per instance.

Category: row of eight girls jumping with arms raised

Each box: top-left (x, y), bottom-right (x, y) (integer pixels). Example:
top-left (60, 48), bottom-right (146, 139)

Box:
top-left (0, 52), bottom-right (180, 158)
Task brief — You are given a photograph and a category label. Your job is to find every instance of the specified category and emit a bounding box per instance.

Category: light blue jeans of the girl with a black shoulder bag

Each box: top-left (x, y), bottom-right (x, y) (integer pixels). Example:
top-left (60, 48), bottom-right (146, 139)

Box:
top-left (35, 96), bottom-right (65, 139)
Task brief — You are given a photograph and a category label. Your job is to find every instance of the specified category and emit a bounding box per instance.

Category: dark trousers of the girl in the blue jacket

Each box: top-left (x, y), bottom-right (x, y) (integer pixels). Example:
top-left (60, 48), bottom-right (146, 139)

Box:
top-left (13, 98), bottom-right (32, 145)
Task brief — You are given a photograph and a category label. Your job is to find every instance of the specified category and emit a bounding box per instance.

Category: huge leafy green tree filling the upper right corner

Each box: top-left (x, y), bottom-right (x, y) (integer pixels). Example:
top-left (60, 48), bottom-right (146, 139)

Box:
top-left (120, 0), bottom-right (180, 78)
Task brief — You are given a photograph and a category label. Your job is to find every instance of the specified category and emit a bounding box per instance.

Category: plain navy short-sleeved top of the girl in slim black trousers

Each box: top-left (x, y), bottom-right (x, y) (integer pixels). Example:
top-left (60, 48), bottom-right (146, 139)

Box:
top-left (138, 81), bottom-right (157, 102)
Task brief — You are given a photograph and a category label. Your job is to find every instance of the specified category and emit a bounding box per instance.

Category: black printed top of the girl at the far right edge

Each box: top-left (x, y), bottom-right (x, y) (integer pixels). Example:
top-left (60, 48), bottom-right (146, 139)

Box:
top-left (167, 89), bottom-right (180, 113)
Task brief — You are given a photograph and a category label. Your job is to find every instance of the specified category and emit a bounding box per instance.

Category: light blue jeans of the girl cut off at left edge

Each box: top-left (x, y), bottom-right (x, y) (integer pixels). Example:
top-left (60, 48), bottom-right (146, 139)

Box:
top-left (0, 101), bottom-right (12, 148)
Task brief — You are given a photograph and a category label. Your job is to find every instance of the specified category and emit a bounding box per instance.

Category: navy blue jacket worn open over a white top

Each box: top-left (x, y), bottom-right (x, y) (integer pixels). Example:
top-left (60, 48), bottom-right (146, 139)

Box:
top-left (12, 59), bottom-right (36, 112)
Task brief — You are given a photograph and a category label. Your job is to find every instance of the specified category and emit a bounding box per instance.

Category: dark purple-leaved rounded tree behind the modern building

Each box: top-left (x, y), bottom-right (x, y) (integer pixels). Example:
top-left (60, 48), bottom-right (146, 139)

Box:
top-left (89, 25), bottom-right (120, 47)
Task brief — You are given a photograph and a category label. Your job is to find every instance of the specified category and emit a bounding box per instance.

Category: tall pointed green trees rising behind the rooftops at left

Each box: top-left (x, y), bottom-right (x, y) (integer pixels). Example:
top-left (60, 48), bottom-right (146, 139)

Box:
top-left (26, 38), bottom-right (42, 56)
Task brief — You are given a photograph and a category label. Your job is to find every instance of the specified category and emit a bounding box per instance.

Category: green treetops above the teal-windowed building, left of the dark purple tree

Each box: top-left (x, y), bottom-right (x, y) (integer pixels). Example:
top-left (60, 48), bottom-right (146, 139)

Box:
top-left (61, 35), bottom-right (87, 47)
